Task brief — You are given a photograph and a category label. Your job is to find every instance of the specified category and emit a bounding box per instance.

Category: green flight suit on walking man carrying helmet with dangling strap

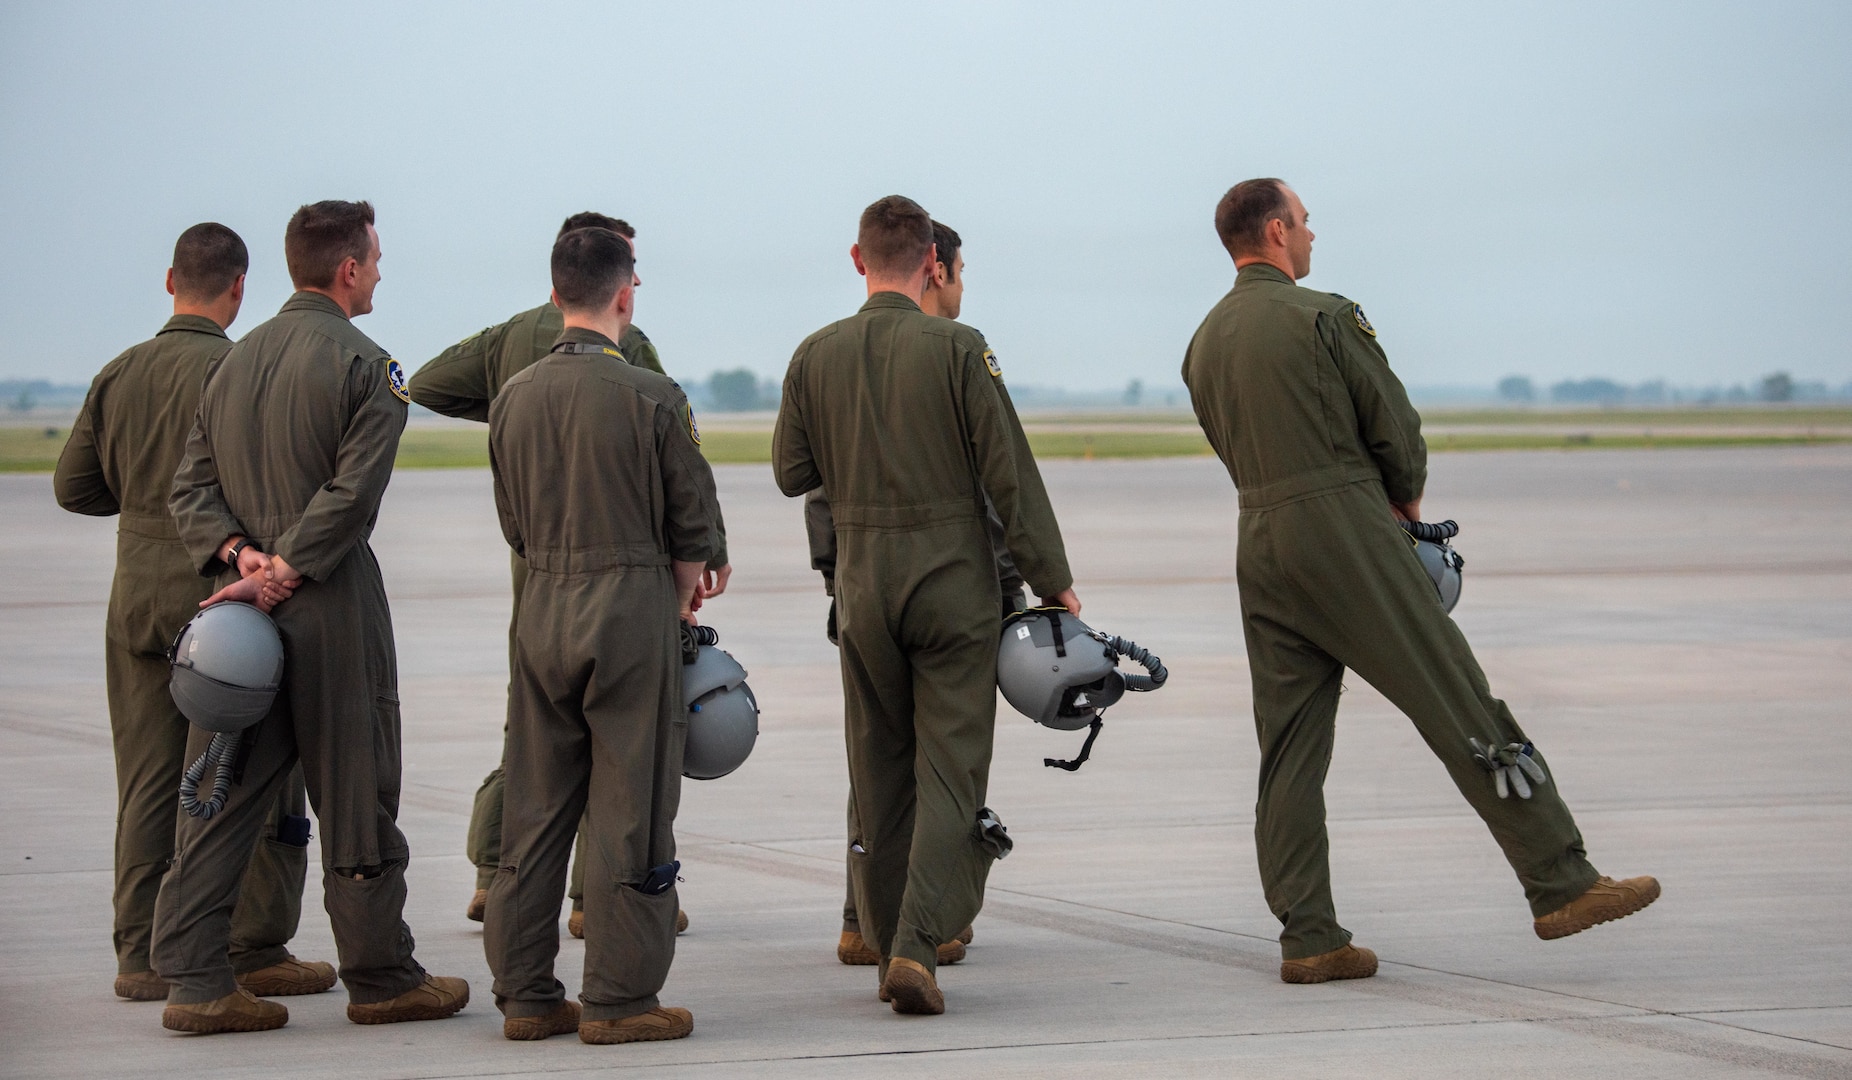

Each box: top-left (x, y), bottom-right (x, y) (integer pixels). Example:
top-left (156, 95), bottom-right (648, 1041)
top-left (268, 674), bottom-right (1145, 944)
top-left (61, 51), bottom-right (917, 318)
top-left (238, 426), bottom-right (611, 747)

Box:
top-left (772, 293), bottom-right (1072, 971)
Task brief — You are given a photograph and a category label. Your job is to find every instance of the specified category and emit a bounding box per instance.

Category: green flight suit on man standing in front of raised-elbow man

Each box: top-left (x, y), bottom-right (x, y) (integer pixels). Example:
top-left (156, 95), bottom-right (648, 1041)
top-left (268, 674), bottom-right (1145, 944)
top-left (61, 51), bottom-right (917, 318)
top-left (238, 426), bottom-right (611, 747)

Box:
top-left (483, 328), bottom-right (719, 1021)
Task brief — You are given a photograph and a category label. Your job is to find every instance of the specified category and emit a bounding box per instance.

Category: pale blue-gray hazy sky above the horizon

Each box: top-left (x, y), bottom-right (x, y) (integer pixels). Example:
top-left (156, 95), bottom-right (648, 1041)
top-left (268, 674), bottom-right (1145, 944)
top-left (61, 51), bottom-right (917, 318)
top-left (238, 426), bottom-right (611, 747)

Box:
top-left (0, 0), bottom-right (1852, 389)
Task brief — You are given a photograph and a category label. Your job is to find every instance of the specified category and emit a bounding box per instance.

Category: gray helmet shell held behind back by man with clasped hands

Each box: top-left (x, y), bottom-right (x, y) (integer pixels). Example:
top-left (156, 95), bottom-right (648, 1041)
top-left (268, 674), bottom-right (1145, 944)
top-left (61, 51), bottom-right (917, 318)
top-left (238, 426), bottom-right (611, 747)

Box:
top-left (167, 600), bottom-right (283, 732)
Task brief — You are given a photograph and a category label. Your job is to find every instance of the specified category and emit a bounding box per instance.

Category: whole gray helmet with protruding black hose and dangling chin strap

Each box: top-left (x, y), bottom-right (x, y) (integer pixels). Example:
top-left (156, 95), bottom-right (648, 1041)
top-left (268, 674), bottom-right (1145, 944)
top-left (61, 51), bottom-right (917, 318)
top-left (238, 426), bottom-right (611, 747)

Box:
top-left (996, 608), bottom-right (1170, 772)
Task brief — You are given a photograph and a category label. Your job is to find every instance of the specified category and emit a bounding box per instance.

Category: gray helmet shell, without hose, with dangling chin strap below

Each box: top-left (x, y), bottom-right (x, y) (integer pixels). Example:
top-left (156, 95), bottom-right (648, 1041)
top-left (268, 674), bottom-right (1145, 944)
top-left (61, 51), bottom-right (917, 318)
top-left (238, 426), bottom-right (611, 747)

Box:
top-left (996, 609), bottom-right (1126, 732)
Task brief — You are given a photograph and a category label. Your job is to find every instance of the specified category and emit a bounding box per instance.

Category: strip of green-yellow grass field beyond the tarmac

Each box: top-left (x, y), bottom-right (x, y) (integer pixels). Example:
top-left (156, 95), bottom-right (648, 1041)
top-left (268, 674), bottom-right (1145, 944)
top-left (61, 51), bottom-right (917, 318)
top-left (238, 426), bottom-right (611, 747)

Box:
top-left (0, 409), bottom-right (1852, 472)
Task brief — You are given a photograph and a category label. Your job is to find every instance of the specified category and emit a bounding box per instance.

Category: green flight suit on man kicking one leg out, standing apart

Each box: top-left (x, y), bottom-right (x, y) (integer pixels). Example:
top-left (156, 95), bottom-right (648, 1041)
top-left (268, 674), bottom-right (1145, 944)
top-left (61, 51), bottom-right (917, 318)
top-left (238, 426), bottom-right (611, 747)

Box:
top-left (1183, 263), bottom-right (1596, 960)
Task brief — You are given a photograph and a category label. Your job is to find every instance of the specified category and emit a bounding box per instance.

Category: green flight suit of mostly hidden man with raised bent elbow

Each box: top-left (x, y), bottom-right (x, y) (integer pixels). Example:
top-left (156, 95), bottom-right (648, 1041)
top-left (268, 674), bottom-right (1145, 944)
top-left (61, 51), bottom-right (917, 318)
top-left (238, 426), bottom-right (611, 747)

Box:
top-left (411, 302), bottom-right (670, 908)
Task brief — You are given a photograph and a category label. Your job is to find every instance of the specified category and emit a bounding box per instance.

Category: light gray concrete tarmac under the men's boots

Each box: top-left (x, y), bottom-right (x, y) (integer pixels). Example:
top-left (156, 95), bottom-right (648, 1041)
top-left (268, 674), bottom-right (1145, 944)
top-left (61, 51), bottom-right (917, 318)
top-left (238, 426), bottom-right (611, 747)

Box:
top-left (0, 446), bottom-right (1852, 1080)
